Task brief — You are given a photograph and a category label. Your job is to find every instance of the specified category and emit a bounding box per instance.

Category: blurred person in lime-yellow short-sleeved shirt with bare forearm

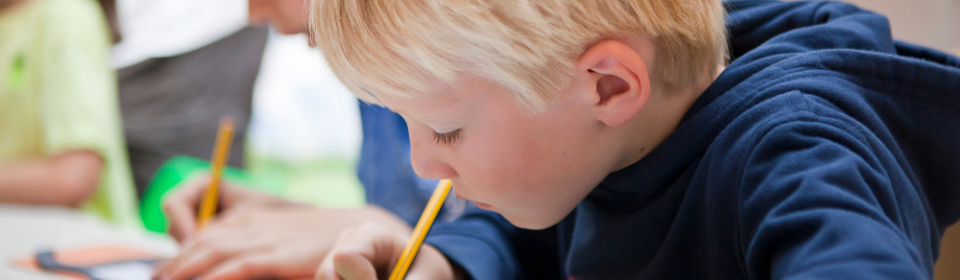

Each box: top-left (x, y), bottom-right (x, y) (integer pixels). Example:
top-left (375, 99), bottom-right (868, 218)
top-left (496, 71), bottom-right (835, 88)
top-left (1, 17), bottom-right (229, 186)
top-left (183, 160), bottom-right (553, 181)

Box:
top-left (0, 0), bottom-right (139, 228)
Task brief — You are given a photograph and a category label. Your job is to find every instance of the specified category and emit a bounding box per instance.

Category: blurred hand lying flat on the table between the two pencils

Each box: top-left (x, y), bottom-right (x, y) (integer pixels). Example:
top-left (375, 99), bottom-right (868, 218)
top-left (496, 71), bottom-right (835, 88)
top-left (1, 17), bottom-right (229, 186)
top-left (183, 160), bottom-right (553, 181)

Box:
top-left (156, 206), bottom-right (411, 280)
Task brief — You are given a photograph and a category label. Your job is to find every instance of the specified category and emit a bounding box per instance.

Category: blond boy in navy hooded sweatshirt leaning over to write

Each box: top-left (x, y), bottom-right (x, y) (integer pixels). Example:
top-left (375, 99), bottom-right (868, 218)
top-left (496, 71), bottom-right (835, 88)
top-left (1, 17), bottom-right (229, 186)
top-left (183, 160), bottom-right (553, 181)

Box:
top-left (311, 0), bottom-right (960, 279)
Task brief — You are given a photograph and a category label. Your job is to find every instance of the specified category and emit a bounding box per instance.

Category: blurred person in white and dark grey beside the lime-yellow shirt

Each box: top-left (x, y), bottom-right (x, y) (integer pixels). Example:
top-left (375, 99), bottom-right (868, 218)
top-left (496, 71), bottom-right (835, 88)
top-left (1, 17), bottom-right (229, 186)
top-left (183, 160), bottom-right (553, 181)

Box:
top-left (112, 0), bottom-right (268, 199)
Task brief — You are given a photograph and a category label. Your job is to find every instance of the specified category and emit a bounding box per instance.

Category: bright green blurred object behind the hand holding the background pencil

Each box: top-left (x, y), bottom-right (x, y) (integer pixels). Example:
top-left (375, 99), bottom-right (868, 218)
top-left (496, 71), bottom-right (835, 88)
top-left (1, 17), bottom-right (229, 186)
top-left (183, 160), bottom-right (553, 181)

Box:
top-left (140, 156), bottom-right (282, 233)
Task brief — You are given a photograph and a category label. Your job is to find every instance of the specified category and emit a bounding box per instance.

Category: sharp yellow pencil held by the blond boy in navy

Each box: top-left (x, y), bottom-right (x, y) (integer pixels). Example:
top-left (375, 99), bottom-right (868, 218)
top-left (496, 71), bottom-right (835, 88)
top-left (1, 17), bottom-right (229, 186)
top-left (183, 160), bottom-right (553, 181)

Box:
top-left (389, 180), bottom-right (450, 280)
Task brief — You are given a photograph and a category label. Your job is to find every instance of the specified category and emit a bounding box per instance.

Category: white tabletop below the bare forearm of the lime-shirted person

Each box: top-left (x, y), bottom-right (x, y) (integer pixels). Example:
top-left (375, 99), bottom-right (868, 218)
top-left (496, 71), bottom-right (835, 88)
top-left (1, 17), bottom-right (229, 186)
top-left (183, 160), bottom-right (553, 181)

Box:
top-left (0, 203), bottom-right (177, 280)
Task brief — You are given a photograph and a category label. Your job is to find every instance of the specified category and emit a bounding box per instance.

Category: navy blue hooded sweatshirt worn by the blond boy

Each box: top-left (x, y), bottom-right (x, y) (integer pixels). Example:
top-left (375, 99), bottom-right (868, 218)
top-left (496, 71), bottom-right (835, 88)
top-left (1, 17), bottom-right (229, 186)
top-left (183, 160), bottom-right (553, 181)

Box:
top-left (428, 1), bottom-right (960, 280)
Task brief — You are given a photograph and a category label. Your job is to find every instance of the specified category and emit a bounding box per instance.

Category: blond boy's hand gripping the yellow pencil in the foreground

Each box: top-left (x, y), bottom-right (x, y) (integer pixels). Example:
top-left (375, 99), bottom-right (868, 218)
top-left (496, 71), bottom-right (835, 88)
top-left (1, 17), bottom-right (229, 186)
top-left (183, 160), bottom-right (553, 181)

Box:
top-left (316, 224), bottom-right (464, 280)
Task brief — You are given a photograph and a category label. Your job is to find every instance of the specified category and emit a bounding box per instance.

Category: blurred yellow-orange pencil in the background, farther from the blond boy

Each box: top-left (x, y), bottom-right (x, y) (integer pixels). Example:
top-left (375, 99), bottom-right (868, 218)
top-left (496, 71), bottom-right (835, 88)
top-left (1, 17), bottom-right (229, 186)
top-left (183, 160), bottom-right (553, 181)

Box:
top-left (197, 117), bottom-right (233, 229)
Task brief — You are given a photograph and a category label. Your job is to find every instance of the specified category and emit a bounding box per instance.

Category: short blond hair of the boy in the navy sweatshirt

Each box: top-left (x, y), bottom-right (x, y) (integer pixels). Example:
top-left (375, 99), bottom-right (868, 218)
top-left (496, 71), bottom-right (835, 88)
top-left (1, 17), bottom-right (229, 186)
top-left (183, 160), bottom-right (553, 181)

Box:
top-left (310, 0), bottom-right (727, 112)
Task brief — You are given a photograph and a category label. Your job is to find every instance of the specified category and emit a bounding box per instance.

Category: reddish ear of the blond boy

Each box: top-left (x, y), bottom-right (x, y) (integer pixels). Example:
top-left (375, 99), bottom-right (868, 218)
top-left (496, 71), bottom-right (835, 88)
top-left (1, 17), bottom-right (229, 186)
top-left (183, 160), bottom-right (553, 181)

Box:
top-left (574, 40), bottom-right (650, 127)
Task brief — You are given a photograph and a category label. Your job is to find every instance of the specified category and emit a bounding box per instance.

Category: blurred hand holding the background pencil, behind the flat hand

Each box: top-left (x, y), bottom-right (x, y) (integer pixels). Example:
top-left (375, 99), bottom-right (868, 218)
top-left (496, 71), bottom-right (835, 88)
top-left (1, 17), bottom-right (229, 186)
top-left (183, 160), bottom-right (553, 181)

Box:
top-left (163, 175), bottom-right (302, 242)
